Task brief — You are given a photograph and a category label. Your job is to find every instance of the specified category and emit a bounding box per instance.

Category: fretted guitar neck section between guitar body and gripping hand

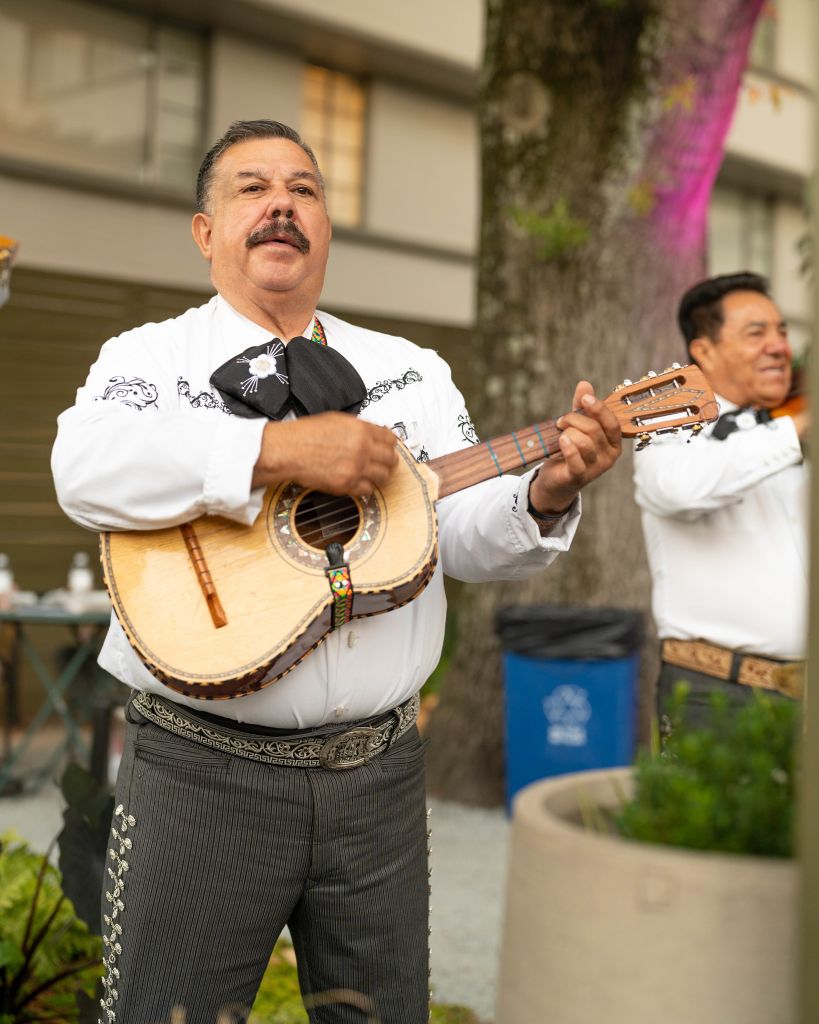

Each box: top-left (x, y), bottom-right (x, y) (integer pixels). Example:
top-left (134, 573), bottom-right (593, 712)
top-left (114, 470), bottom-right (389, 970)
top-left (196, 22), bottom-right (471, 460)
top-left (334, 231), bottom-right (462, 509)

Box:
top-left (426, 420), bottom-right (560, 499)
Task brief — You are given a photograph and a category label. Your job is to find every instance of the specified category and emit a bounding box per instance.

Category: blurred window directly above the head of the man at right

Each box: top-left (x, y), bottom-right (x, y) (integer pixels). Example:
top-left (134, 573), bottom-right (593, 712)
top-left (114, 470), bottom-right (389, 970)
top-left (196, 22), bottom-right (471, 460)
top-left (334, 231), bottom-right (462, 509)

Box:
top-left (708, 185), bottom-right (774, 278)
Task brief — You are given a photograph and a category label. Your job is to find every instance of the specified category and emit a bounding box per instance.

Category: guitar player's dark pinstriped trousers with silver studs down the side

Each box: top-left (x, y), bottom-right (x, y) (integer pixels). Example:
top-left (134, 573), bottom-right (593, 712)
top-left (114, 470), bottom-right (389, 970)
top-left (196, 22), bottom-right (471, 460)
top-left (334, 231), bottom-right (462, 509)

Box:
top-left (100, 706), bottom-right (429, 1024)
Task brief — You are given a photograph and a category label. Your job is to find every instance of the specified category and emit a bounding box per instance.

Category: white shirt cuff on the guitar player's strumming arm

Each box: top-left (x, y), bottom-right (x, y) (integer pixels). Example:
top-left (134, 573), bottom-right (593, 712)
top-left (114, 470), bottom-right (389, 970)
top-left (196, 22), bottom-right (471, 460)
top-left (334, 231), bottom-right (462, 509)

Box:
top-left (203, 416), bottom-right (268, 526)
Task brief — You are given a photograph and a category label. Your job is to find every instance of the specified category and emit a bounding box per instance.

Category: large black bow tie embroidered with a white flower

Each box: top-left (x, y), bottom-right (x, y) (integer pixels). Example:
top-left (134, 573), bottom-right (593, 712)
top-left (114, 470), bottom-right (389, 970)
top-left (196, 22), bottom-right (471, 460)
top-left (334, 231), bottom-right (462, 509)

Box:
top-left (211, 338), bottom-right (367, 420)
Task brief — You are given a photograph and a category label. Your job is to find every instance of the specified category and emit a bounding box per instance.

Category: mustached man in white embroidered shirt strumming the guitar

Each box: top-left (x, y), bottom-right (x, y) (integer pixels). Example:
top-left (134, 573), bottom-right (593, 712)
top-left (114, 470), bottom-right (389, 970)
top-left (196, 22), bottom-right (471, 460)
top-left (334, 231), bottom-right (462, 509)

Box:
top-left (53, 121), bottom-right (620, 1024)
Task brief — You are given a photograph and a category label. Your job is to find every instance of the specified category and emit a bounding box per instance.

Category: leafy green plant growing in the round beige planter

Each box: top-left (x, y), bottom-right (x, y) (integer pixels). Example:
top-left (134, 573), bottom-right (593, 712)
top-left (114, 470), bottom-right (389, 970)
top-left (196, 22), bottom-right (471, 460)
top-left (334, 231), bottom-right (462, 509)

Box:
top-left (615, 685), bottom-right (800, 857)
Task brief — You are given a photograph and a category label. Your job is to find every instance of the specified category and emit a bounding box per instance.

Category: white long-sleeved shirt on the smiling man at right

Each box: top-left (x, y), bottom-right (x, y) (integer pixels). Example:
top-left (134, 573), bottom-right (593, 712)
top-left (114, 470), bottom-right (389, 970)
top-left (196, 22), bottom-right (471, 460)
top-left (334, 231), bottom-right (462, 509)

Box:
top-left (634, 395), bottom-right (808, 659)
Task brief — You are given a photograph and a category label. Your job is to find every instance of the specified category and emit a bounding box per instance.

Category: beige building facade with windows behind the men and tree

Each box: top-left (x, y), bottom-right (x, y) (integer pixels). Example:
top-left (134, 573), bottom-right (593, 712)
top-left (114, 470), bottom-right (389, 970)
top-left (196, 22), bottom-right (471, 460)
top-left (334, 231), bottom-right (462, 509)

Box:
top-left (0, 0), bottom-right (814, 591)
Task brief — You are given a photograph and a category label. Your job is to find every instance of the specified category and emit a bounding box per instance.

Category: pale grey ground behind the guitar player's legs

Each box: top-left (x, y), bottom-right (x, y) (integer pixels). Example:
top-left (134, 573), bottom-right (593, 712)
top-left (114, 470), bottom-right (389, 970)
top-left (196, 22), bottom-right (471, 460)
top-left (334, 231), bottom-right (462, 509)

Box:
top-left (0, 733), bottom-right (509, 1021)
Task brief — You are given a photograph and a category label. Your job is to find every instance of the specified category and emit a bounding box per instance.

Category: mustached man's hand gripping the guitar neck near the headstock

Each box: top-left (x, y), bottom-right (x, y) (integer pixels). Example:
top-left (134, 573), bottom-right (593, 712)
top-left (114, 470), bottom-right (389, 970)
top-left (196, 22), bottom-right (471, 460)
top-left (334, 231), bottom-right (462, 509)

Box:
top-left (529, 381), bottom-right (621, 515)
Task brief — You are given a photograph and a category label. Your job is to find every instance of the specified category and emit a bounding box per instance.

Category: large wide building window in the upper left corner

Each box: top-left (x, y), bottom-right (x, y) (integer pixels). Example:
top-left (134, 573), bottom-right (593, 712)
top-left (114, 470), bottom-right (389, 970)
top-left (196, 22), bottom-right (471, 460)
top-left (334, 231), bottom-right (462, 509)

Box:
top-left (0, 0), bottom-right (205, 191)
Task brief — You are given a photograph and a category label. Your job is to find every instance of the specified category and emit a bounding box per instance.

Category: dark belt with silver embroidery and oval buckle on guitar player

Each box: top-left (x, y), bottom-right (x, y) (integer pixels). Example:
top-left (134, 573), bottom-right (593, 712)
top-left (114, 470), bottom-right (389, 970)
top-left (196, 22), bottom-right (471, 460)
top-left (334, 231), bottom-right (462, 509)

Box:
top-left (131, 692), bottom-right (421, 771)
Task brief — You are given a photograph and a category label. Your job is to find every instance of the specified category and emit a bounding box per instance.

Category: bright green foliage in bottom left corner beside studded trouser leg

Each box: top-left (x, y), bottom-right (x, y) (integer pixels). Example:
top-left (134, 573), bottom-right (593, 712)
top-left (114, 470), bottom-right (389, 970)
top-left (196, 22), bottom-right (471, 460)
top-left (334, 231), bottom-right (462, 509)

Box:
top-left (0, 834), bottom-right (102, 1024)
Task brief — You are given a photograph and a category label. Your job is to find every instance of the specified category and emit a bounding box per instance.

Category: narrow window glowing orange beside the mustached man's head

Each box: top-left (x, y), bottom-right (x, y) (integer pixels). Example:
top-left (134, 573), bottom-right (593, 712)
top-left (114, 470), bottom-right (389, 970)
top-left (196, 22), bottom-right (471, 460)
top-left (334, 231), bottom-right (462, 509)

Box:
top-left (301, 65), bottom-right (367, 227)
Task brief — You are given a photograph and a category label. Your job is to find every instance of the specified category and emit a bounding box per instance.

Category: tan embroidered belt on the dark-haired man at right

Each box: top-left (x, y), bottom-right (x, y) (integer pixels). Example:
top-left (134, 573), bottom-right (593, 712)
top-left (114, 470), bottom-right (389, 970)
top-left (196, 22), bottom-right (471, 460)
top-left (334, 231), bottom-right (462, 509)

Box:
top-left (660, 640), bottom-right (805, 698)
